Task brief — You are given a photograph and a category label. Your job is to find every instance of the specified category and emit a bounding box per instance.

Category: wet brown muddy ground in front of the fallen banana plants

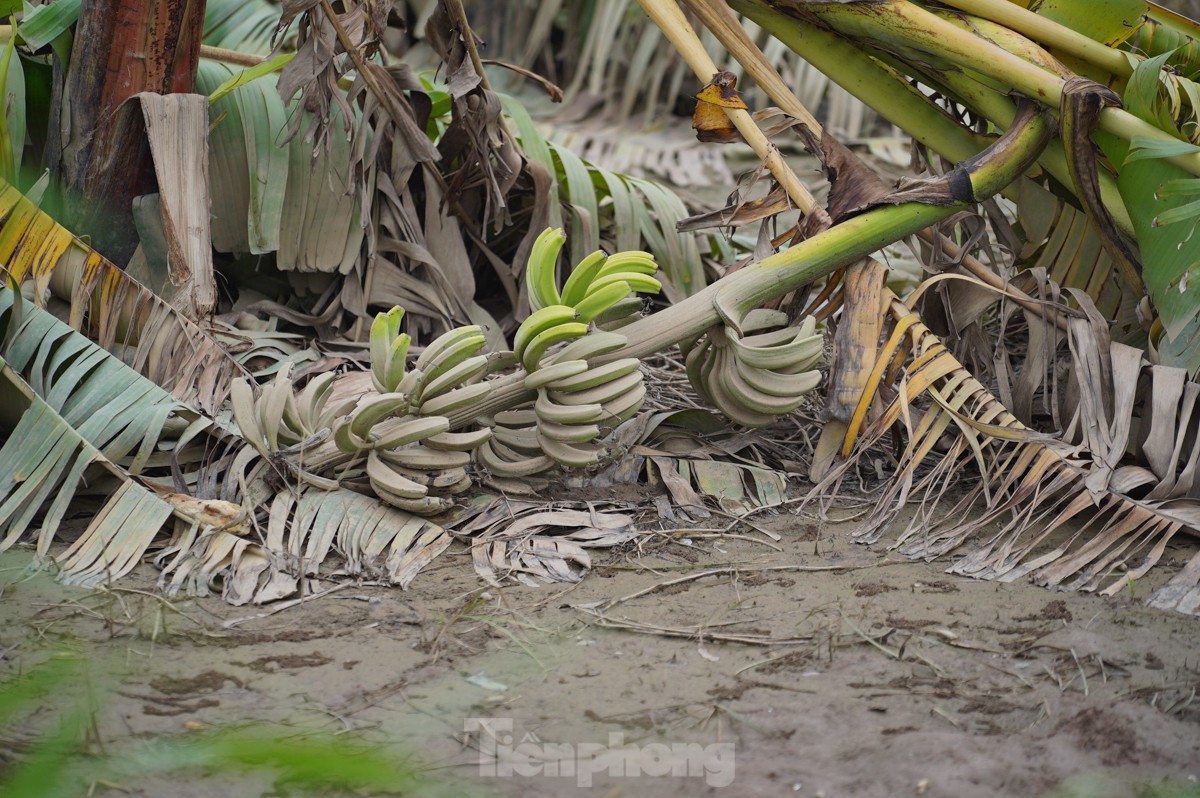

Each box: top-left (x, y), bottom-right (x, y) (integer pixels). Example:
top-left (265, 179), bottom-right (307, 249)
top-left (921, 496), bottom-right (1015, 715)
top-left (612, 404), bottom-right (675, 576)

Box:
top-left (0, 504), bottom-right (1200, 798)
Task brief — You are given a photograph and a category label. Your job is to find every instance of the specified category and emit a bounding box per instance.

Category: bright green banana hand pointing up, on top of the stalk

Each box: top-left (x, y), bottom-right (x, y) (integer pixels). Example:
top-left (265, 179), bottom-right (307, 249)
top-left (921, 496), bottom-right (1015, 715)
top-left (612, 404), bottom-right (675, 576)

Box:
top-left (512, 228), bottom-right (662, 371)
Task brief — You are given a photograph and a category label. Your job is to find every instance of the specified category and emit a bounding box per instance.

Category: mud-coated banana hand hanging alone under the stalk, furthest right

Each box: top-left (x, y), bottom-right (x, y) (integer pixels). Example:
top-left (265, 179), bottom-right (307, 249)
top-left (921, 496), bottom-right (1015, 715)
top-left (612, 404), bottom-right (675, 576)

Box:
top-left (685, 310), bottom-right (824, 427)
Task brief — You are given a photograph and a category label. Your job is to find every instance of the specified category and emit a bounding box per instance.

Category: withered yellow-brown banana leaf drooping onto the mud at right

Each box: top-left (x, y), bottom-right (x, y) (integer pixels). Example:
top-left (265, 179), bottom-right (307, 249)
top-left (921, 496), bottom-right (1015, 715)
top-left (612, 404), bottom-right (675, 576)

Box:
top-left (811, 294), bottom-right (1200, 611)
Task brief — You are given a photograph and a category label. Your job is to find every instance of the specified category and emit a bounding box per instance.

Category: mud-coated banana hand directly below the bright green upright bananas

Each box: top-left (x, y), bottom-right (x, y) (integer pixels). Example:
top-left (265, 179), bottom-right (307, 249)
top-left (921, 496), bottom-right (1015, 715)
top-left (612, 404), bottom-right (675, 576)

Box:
top-left (524, 331), bottom-right (646, 468)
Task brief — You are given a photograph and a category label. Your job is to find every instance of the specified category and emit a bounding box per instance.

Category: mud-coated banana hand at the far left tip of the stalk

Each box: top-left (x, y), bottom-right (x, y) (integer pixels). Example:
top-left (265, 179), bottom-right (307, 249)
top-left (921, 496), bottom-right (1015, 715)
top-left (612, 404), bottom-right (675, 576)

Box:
top-left (230, 364), bottom-right (354, 455)
